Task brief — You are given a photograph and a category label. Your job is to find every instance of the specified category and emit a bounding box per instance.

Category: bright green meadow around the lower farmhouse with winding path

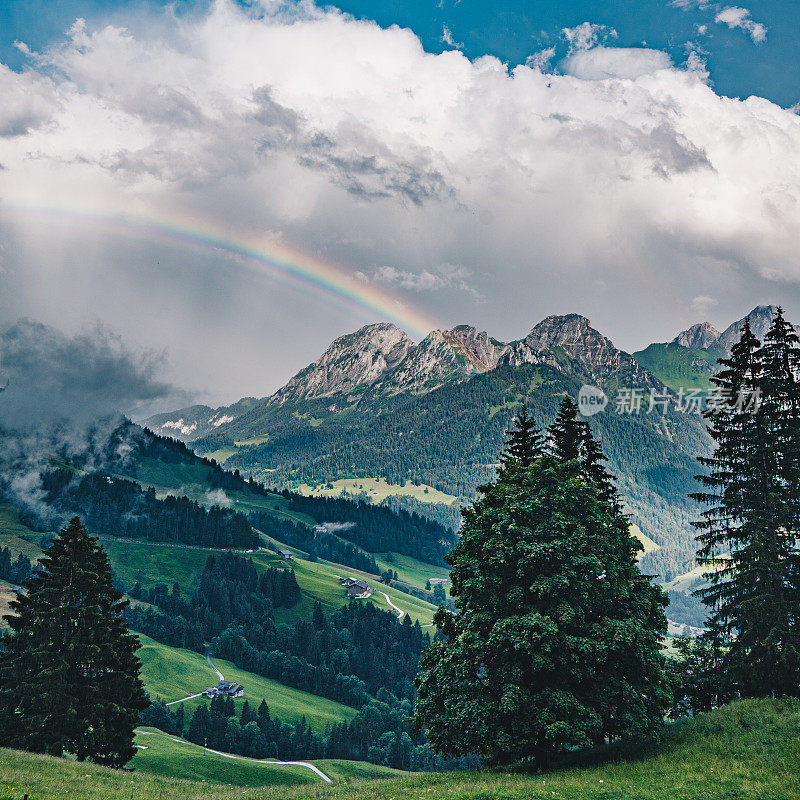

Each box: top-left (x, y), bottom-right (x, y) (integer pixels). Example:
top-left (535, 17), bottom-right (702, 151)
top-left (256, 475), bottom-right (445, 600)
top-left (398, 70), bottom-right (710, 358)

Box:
top-left (138, 634), bottom-right (356, 731)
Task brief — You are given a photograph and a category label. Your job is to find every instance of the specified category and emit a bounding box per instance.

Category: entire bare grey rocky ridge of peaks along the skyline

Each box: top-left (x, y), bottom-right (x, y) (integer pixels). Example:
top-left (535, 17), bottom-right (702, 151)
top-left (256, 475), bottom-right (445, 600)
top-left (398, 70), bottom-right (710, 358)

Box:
top-left (144, 306), bottom-right (775, 441)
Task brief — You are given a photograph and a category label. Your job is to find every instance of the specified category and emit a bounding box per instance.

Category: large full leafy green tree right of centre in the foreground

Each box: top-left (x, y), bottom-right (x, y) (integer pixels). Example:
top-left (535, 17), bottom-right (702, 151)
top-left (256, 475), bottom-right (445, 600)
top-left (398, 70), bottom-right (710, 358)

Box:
top-left (414, 410), bottom-right (668, 765)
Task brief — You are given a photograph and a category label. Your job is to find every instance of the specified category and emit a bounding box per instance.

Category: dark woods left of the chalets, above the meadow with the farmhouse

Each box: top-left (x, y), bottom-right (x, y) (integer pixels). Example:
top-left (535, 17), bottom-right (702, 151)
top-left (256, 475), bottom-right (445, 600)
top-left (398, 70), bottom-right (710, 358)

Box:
top-left (126, 553), bottom-right (300, 651)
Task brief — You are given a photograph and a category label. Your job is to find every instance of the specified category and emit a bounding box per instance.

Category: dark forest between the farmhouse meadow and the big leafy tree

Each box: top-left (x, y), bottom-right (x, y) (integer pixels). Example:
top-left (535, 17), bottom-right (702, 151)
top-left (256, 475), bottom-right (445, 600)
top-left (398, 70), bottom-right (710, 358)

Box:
top-left (211, 603), bottom-right (430, 708)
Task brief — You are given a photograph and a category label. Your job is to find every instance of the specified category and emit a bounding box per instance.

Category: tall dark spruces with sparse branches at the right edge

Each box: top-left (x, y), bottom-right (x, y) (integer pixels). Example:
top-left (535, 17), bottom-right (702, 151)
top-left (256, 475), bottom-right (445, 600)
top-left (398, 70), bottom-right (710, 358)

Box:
top-left (695, 310), bottom-right (800, 696)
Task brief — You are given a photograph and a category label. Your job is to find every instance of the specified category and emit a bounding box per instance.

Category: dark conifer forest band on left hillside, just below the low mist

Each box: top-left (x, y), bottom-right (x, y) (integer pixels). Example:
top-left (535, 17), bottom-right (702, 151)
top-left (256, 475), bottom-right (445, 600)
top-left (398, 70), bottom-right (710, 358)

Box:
top-left (20, 469), bottom-right (258, 548)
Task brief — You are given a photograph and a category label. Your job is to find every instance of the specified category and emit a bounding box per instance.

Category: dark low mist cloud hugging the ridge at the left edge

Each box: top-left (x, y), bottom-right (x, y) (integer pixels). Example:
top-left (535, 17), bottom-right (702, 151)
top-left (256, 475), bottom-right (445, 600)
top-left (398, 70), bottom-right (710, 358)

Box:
top-left (0, 319), bottom-right (174, 429)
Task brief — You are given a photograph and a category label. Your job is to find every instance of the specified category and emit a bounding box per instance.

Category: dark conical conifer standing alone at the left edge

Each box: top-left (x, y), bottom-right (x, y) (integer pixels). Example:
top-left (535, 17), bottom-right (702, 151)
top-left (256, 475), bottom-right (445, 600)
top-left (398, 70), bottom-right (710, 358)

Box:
top-left (0, 518), bottom-right (149, 767)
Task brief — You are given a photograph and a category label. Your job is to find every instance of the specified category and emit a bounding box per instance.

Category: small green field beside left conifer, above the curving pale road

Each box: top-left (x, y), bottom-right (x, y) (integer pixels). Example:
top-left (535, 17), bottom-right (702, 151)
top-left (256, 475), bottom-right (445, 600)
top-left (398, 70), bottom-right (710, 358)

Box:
top-left (129, 728), bottom-right (312, 787)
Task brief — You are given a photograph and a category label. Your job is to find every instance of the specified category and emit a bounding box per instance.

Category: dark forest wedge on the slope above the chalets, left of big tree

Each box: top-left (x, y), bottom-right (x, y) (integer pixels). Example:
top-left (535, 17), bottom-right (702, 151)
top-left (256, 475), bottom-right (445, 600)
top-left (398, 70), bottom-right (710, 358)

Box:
top-left (282, 490), bottom-right (456, 566)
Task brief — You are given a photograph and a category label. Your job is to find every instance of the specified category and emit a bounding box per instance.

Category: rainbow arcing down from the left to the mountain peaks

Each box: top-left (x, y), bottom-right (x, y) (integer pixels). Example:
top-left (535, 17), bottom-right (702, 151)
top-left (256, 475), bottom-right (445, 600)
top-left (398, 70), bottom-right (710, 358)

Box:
top-left (0, 200), bottom-right (439, 339)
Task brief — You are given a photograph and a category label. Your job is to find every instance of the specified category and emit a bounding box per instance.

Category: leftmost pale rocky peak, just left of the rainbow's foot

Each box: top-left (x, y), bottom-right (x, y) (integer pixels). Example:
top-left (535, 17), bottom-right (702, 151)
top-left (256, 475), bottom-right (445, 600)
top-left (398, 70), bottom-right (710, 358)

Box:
top-left (272, 322), bottom-right (414, 402)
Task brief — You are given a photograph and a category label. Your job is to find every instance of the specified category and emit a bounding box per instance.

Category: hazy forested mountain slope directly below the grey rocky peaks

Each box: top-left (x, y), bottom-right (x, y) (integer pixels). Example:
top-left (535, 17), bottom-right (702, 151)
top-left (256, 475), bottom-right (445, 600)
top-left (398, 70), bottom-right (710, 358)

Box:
top-left (194, 364), bottom-right (709, 572)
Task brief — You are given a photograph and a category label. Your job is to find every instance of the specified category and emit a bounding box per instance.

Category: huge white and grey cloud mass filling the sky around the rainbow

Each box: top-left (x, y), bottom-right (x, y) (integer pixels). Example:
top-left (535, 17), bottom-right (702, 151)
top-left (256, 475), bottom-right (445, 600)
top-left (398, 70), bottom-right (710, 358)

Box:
top-left (0, 0), bottom-right (800, 401)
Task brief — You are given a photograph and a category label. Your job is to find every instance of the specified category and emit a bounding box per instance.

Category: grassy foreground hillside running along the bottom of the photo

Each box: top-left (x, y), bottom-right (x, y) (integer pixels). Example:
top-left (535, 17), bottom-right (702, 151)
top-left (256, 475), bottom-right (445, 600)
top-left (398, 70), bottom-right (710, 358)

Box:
top-left (0, 700), bottom-right (800, 800)
